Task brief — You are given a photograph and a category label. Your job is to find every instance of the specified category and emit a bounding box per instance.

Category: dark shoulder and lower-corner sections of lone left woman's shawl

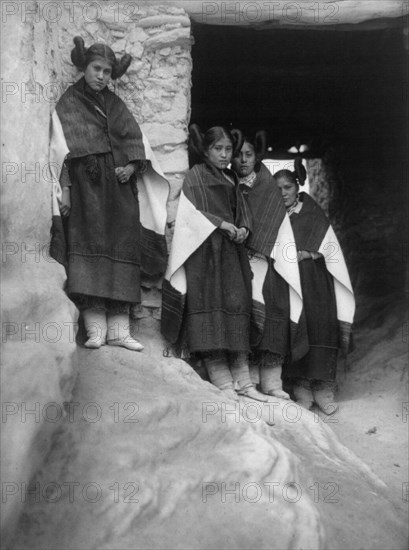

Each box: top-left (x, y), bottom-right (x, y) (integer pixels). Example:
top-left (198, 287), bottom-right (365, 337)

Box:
top-left (50, 77), bottom-right (167, 277)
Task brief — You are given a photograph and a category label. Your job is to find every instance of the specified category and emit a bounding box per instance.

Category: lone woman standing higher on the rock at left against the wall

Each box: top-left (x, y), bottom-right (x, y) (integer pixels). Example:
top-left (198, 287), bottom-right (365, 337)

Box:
top-left (50, 36), bottom-right (169, 351)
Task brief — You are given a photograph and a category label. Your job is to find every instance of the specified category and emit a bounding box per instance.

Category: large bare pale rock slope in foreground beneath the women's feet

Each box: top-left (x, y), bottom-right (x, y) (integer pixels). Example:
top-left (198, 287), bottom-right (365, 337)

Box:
top-left (10, 328), bottom-right (406, 550)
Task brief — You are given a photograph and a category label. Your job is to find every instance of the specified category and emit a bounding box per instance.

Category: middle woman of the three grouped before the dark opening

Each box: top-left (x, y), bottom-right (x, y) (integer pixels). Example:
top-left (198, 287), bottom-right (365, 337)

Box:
top-left (232, 131), bottom-right (308, 399)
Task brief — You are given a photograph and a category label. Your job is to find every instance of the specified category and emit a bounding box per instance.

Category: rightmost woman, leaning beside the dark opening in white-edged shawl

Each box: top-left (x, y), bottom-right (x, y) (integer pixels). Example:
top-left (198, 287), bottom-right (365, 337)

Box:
top-left (274, 158), bottom-right (355, 414)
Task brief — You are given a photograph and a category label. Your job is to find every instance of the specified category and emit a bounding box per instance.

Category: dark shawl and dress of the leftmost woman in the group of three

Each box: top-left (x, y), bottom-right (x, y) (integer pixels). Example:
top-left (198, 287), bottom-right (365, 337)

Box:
top-left (162, 163), bottom-right (251, 353)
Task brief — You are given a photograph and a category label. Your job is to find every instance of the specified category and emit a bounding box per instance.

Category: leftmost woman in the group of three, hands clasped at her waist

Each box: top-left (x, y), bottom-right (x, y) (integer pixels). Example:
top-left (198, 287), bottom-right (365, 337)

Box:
top-left (162, 125), bottom-right (266, 401)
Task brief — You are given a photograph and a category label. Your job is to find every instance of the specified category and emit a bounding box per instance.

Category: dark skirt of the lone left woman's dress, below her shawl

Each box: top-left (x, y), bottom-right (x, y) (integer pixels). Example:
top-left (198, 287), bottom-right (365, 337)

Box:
top-left (67, 149), bottom-right (141, 302)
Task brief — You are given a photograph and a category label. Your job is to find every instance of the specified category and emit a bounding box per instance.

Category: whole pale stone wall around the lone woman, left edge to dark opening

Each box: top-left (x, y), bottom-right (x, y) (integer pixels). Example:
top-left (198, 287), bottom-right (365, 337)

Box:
top-left (2, 1), bottom-right (192, 543)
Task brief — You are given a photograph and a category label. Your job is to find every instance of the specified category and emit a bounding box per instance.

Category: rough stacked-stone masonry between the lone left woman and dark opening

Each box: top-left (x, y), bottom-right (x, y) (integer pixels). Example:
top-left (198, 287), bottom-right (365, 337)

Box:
top-left (47, 1), bottom-right (192, 328)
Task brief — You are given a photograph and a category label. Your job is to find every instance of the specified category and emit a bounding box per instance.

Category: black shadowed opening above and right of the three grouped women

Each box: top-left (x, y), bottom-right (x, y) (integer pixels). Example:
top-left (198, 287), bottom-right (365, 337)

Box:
top-left (191, 24), bottom-right (409, 302)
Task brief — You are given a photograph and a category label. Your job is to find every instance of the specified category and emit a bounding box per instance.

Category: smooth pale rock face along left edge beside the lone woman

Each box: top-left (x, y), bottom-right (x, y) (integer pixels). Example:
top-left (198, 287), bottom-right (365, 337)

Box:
top-left (1, 10), bottom-right (76, 543)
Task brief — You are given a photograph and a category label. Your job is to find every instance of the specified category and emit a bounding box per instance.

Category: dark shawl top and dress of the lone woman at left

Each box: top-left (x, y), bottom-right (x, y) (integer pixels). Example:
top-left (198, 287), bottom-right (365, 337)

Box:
top-left (51, 78), bottom-right (160, 303)
